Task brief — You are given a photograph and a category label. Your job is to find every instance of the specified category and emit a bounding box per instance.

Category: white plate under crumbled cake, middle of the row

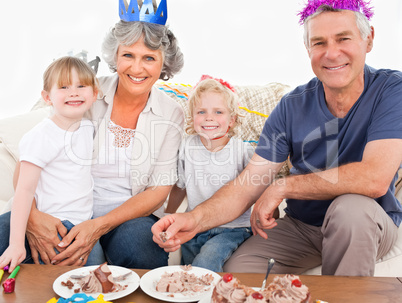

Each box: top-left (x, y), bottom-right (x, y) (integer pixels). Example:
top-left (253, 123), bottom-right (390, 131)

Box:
top-left (140, 265), bottom-right (221, 302)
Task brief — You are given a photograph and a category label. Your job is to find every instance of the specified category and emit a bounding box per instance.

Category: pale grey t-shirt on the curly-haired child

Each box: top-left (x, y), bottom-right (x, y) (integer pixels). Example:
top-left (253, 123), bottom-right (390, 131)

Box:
top-left (177, 135), bottom-right (254, 228)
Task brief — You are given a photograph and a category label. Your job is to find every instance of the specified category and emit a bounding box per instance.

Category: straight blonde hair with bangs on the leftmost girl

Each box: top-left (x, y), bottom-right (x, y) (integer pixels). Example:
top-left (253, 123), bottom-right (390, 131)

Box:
top-left (43, 56), bottom-right (100, 92)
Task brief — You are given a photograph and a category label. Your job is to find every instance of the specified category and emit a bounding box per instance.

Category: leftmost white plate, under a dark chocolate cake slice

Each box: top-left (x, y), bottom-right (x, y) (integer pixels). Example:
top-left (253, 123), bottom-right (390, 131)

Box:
top-left (53, 265), bottom-right (140, 301)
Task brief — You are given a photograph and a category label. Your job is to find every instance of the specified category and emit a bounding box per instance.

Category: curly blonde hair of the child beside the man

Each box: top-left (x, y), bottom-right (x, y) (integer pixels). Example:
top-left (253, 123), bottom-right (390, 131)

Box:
top-left (185, 79), bottom-right (244, 137)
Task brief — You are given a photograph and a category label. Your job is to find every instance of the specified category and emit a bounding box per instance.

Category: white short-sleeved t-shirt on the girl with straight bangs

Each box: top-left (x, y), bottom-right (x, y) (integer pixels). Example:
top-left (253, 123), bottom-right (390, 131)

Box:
top-left (19, 118), bottom-right (94, 224)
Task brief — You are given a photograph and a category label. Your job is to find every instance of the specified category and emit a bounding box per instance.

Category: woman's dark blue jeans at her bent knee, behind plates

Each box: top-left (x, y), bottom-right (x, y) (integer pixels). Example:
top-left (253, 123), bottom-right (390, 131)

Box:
top-left (100, 215), bottom-right (168, 269)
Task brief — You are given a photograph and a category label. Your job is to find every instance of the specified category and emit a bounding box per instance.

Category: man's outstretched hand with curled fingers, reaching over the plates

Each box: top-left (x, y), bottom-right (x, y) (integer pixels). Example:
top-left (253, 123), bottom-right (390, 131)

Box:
top-left (151, 212), bottom-right (200, 252)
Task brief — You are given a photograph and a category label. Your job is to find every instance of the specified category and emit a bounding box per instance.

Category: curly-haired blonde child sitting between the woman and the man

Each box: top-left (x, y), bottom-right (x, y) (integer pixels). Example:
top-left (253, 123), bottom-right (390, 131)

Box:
top-left (165, 76), bottom-right (254, 272)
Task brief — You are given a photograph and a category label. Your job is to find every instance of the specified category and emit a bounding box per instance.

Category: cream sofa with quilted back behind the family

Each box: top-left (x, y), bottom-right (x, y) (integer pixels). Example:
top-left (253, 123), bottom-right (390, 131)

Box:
top-left (0, 82), bottom-right (402, 277)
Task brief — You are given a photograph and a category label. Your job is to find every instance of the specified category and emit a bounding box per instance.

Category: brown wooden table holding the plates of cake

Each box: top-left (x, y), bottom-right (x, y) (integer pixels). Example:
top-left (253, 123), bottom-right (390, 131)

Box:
top-left (0, 264), bottom-right (402, 303)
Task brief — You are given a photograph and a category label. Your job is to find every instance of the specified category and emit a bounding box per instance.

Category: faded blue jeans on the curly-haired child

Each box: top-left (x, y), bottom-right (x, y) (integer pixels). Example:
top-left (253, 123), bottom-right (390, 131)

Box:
top-left (181, 227), bottom-right (252, 272)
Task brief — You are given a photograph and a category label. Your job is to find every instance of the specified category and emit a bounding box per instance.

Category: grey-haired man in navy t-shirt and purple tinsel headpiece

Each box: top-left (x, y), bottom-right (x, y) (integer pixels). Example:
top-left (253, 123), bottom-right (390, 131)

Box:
top-left (152, 0), bottom-right (402, 276)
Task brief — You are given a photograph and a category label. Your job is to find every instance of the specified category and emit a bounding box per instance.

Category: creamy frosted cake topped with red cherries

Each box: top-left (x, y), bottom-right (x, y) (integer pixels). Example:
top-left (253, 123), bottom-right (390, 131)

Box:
top-left (211, 274), bottom-right (310, 303)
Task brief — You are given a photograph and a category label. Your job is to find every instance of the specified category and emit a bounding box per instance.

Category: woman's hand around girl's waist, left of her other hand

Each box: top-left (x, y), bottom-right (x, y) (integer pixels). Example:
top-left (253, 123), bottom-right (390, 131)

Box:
top-left (26, 207), bottom-right (67, 264)
